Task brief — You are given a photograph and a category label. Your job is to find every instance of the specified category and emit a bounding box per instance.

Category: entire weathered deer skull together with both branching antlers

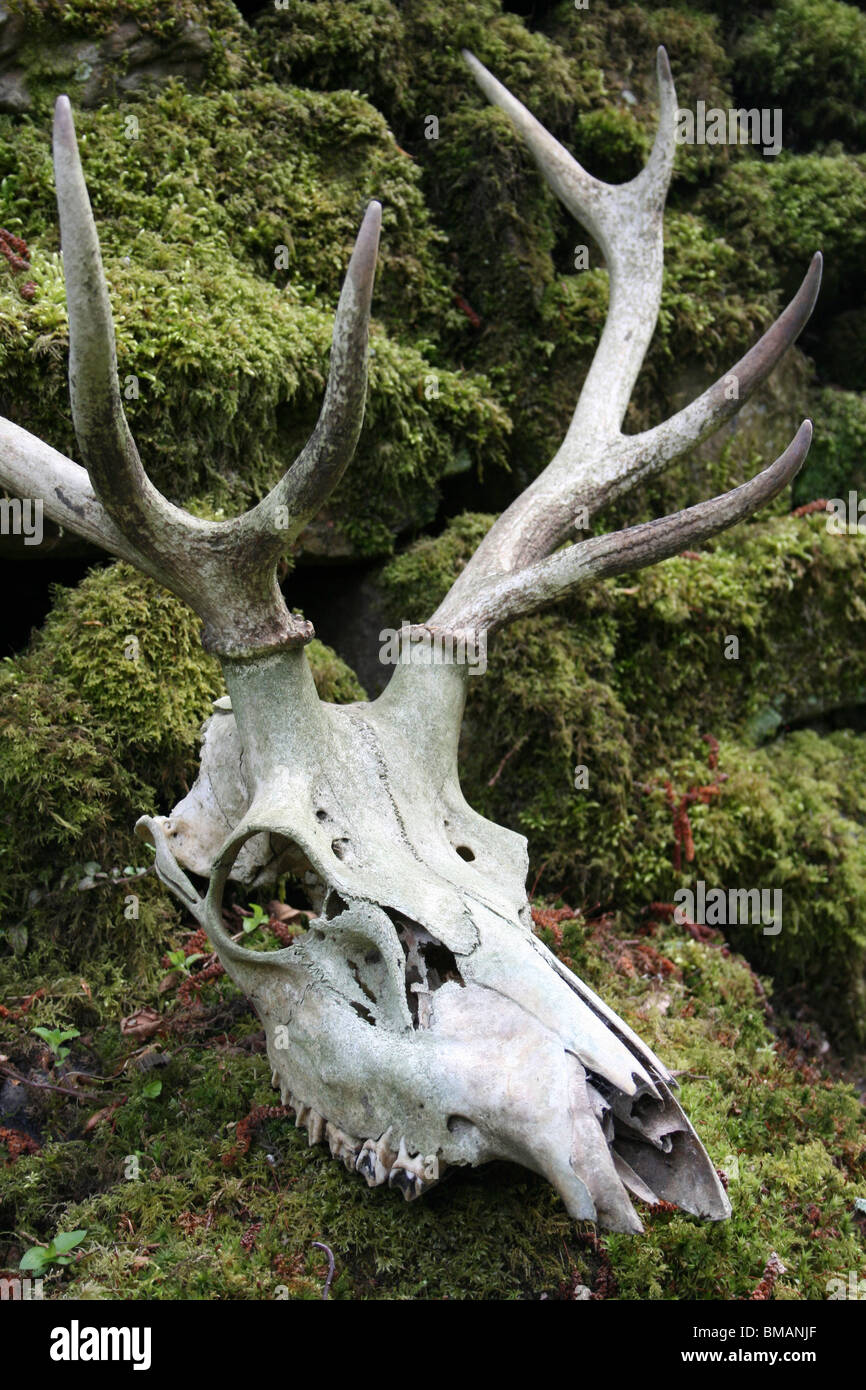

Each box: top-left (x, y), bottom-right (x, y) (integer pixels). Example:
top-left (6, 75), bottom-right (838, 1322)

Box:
top-left (0, 50), bottom-right (820, 1232)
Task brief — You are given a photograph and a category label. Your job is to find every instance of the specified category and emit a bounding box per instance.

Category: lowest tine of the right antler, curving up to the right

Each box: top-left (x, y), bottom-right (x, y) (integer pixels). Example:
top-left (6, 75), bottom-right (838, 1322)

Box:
top-left (430, 420), bottom-right (812, 632)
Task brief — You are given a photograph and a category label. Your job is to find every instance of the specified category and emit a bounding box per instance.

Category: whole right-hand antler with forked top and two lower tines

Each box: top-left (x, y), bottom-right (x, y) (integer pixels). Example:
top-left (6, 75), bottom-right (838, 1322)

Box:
top-left (430, 49), bottom-right (822, 630)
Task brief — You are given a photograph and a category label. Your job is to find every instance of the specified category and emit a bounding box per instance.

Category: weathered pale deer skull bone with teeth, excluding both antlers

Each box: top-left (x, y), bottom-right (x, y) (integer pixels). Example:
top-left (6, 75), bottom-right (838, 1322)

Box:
top-left (139, 652), bottom-right (730, 1232)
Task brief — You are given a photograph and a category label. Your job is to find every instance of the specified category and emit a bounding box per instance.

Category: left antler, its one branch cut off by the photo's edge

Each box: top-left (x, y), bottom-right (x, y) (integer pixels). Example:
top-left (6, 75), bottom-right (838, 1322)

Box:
top-left (0, 96), bottom-right (381, 657)
